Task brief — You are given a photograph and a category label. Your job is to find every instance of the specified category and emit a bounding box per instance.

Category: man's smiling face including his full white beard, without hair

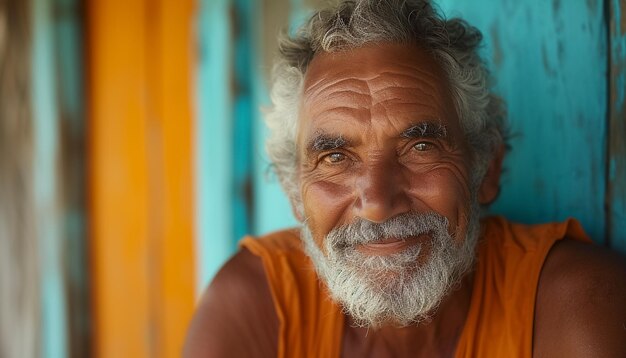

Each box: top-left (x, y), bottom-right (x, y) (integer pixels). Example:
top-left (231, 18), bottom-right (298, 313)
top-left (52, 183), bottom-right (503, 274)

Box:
top-left (297, 44), bottom-right (477, 324)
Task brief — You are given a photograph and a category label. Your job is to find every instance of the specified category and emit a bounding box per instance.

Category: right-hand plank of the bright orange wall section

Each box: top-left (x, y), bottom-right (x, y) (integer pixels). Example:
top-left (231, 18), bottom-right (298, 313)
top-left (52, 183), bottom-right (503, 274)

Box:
top-left (150, 0), bottom-right (195, 357)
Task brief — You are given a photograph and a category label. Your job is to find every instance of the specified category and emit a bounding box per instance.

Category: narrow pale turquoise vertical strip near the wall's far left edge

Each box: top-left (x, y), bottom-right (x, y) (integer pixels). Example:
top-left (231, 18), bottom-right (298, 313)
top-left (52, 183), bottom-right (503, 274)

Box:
top-left (31, 0), bottom-right (68, 358)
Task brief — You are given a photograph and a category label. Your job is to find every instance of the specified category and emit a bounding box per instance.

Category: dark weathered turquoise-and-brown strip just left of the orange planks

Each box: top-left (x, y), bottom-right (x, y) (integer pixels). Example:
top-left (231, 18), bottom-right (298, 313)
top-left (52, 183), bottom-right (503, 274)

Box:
top-left (53, 0), bottom-right (91, 357)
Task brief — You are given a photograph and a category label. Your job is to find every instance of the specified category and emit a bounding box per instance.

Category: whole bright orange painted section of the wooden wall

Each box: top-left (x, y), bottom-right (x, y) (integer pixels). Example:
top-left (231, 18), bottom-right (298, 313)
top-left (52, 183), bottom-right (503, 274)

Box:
top-left (87, 0), bottom-right (195, 357)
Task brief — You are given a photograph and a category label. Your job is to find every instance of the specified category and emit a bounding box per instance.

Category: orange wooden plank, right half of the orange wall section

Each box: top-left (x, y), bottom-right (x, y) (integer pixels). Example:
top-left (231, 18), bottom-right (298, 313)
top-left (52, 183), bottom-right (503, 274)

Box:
top-left (147, 0), bottom-right (195, 357)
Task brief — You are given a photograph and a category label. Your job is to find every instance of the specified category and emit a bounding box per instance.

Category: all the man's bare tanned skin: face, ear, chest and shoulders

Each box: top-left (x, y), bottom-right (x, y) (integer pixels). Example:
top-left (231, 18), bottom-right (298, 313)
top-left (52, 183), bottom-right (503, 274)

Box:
top-left (184, 44), bottom-right (626, 358)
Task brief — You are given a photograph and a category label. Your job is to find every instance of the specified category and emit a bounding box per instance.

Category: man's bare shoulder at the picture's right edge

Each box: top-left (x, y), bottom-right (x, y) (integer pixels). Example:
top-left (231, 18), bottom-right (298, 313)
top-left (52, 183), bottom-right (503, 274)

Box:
top-left (533, 239), bottom-right (626, 357)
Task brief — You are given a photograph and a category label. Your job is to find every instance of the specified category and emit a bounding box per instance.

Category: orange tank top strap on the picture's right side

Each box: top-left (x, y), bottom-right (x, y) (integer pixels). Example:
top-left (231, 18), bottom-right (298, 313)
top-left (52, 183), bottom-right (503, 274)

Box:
top-left (456, 217), bottom-right (590, 358)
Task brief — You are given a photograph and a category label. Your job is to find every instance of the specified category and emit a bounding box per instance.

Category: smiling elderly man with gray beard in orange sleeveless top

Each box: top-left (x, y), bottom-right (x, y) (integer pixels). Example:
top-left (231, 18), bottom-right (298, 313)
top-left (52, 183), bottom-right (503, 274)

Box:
top-left (185, 0), bottom-right (626, 357)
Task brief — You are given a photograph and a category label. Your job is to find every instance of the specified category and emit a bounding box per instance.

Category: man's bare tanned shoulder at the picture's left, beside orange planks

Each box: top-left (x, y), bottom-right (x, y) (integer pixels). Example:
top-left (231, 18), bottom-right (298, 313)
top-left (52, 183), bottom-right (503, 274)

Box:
top-left (183, 249), bottom-right (278, 358)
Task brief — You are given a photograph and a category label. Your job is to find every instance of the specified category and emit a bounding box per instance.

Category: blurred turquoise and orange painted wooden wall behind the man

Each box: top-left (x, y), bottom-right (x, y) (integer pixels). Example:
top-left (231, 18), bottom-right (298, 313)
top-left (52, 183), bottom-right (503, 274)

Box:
top-left (0, 0), bottom-right (626, 358)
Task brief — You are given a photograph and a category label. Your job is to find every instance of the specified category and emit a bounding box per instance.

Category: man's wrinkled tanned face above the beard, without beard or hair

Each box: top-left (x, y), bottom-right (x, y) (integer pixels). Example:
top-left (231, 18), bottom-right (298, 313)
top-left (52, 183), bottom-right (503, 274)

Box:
top-left (298, 44), bottom-right (470, 255)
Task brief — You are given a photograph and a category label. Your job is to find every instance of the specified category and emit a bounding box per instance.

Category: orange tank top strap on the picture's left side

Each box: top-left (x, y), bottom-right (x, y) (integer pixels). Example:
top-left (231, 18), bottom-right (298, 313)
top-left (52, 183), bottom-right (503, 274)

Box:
top-left (240, 230), bottom-right (343, 357)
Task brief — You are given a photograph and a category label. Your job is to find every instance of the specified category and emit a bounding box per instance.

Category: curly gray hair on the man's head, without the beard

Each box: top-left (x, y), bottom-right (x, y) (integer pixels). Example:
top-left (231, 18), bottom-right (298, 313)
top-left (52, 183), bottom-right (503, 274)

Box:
top-left (265, 0), bottom-right (506, 204)
